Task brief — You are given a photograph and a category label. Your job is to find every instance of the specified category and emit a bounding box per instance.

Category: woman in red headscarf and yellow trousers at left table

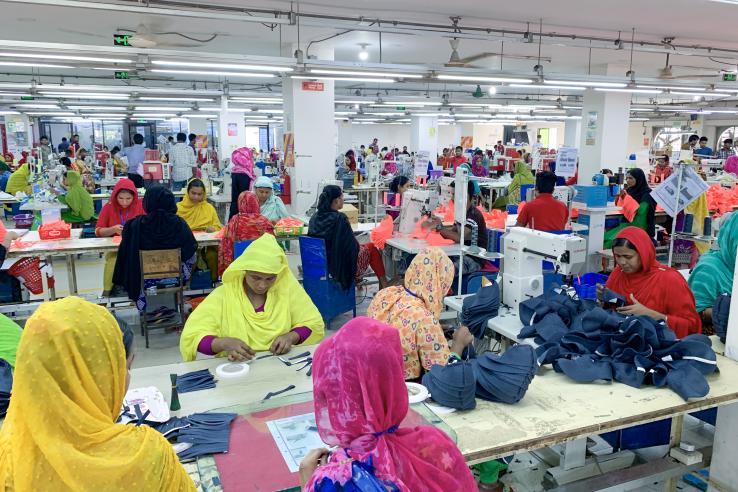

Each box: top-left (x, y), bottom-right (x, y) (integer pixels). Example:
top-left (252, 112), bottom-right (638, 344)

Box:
top-left (95, 178), bottom-right (144, 296)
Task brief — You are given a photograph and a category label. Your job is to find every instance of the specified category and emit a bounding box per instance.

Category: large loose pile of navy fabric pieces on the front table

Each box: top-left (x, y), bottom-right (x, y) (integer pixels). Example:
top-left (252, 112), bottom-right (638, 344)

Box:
top-left (520, 291), bottom-right (717, 400)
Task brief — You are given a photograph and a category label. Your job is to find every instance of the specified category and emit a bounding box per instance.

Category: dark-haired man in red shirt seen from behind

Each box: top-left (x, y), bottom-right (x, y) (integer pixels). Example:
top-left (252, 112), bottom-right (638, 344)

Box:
top-left (517, 171), bottom-right (569, 231)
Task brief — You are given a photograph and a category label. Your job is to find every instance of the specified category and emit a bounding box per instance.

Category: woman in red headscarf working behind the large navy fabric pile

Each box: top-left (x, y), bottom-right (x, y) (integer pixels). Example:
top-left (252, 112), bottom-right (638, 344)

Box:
top-left (605, 226), bottom-right (702, 338)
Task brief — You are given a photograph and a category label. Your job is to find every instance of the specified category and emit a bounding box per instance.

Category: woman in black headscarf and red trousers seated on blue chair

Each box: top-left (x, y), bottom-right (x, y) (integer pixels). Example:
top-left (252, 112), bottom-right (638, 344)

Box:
top-left (308, 185), bottom-right (387, 290)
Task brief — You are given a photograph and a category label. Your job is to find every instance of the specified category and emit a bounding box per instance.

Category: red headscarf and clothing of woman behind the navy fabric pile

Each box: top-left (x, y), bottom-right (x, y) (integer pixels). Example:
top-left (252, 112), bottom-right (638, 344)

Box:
top-left (605, 226), bottom-right (702, 338)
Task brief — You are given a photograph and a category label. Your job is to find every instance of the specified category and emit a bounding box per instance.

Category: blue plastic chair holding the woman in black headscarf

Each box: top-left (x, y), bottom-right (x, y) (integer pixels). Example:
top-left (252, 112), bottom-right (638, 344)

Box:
top-left (299, 236), bottom-right (356, 329)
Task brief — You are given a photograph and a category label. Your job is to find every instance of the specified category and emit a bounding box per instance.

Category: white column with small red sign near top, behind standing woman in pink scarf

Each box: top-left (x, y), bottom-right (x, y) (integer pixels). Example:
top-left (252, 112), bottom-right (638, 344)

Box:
top-left (282, 49), bottom-right (337, 214)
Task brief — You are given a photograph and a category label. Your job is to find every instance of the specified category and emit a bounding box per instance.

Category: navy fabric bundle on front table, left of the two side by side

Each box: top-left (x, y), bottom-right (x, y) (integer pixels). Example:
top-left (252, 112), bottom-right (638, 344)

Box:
top-left (423, 361), bottom-right (477, 410)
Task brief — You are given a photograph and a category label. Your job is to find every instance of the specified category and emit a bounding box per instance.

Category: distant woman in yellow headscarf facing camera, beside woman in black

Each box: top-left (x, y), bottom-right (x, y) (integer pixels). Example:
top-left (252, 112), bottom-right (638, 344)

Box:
top-left (177, 179), bottom-right (223, 282)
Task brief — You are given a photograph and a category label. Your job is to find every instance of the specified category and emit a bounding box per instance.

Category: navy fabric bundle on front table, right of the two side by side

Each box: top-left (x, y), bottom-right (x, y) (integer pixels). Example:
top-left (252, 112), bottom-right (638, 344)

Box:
top-left (472, 345), bottom-right (538, 404)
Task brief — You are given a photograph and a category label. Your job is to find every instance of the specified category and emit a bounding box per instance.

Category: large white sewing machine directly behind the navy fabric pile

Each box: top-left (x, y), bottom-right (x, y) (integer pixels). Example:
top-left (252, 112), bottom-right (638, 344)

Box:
top-left (502, 227), bottom-right (587, 311)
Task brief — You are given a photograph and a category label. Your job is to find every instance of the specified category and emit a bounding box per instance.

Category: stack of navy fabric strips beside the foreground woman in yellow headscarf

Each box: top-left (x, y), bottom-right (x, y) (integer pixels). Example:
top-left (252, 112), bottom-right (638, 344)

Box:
top-left (154, 413), bottom-right (237, 461)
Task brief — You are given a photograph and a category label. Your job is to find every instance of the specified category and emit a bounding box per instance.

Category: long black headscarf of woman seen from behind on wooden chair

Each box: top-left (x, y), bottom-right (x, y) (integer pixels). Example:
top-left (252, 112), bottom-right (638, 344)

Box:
top-left (113, 185), bottom-right (197, 300)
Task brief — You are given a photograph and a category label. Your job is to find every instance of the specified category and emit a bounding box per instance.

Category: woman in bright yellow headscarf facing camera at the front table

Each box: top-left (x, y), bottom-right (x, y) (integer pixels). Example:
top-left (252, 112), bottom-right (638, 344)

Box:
top-left (179, 234), bottom-right (324, 361)
